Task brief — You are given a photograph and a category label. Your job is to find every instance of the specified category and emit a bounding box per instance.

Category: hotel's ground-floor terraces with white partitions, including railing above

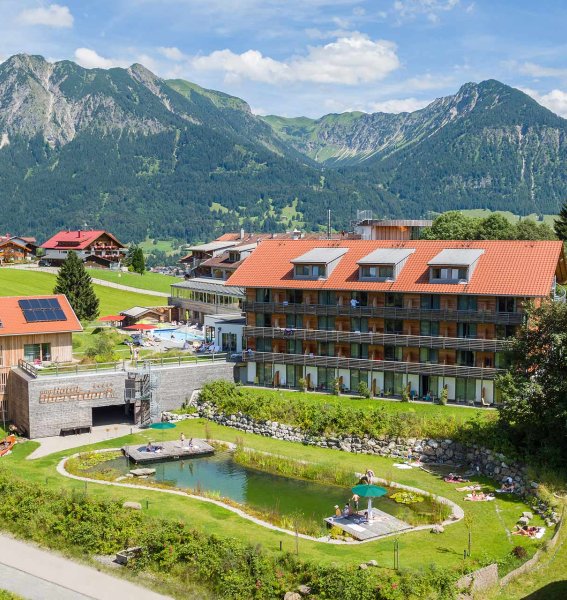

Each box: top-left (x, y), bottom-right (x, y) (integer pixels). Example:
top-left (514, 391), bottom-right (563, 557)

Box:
top-left (244, 351), bottom-right (498, 405)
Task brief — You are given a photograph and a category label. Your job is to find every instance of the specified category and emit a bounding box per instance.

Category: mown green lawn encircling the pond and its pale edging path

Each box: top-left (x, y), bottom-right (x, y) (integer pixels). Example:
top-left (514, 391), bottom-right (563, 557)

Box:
top-left (2, 419), bottom-right (552, 568)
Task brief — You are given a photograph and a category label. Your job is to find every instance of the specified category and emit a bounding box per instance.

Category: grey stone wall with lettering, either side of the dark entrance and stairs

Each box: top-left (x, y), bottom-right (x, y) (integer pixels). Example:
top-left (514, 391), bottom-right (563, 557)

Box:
top-left (9, 361), bottom-right (234, 438)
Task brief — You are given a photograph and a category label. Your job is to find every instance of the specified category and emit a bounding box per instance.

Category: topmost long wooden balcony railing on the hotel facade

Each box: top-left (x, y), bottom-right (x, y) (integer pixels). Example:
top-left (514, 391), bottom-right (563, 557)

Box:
top-left (243, 301), bottom-right (525, 325)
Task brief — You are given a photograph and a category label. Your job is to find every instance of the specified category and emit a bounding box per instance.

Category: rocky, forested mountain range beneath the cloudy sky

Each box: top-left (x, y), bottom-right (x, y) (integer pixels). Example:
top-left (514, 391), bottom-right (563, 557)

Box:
top-left (0, 55), bottom-right (567, 242)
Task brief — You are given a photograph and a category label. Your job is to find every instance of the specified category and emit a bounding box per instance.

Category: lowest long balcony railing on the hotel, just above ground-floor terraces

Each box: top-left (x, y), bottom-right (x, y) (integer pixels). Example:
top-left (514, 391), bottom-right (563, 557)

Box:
top-left (243, 351), bottom-right (503, 379)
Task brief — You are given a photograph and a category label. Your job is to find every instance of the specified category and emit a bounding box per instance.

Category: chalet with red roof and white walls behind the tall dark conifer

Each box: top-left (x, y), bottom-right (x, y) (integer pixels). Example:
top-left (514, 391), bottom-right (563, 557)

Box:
top-left (41, 230), bottom-right (126, 268)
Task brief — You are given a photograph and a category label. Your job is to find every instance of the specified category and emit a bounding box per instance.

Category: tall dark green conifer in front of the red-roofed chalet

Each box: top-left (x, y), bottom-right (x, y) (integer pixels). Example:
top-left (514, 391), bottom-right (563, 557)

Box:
top-left (53, 252), bottom-right (99, 321)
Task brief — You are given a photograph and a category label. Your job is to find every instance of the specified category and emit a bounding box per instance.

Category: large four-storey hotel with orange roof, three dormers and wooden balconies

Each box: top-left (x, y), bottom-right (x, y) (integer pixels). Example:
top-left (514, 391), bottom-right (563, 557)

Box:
top-left (227, 240), bottom-right (567, 404)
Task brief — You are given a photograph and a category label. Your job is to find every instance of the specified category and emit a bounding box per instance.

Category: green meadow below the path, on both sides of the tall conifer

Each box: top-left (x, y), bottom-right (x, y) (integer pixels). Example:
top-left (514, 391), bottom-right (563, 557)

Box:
top-left (0, 269), bottom-right (165, 315)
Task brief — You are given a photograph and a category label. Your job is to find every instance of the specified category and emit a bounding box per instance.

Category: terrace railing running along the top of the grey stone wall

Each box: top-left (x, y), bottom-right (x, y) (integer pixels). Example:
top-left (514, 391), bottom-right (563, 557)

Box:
top-left (31, 352), bottom-right (230, 377)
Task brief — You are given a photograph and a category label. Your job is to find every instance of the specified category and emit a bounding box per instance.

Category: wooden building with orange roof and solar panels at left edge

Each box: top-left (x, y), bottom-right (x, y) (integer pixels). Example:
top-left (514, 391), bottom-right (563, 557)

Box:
top-left (0, 295), bottom-right (83, 416)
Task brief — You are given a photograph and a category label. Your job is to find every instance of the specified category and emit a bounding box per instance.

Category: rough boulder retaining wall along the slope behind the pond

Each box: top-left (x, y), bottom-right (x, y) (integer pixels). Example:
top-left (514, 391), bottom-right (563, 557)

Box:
top-left (172, 398), bottom-right (527, 493)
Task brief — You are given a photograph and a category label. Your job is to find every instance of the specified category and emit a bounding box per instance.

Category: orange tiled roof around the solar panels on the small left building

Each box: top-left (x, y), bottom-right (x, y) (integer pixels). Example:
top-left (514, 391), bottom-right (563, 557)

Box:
top-left (0, 294), bottom-right (83, 336)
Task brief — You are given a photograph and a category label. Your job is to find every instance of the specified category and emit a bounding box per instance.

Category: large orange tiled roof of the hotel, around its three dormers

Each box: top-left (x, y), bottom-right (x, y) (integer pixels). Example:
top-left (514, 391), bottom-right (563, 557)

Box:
top-left (227, 239), bottom-right (565, 297)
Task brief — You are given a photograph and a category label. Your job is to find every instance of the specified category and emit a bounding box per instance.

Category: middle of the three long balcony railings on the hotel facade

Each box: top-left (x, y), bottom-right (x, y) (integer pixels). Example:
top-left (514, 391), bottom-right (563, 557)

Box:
top-left (244, 327), bottom-right (508, 352)
